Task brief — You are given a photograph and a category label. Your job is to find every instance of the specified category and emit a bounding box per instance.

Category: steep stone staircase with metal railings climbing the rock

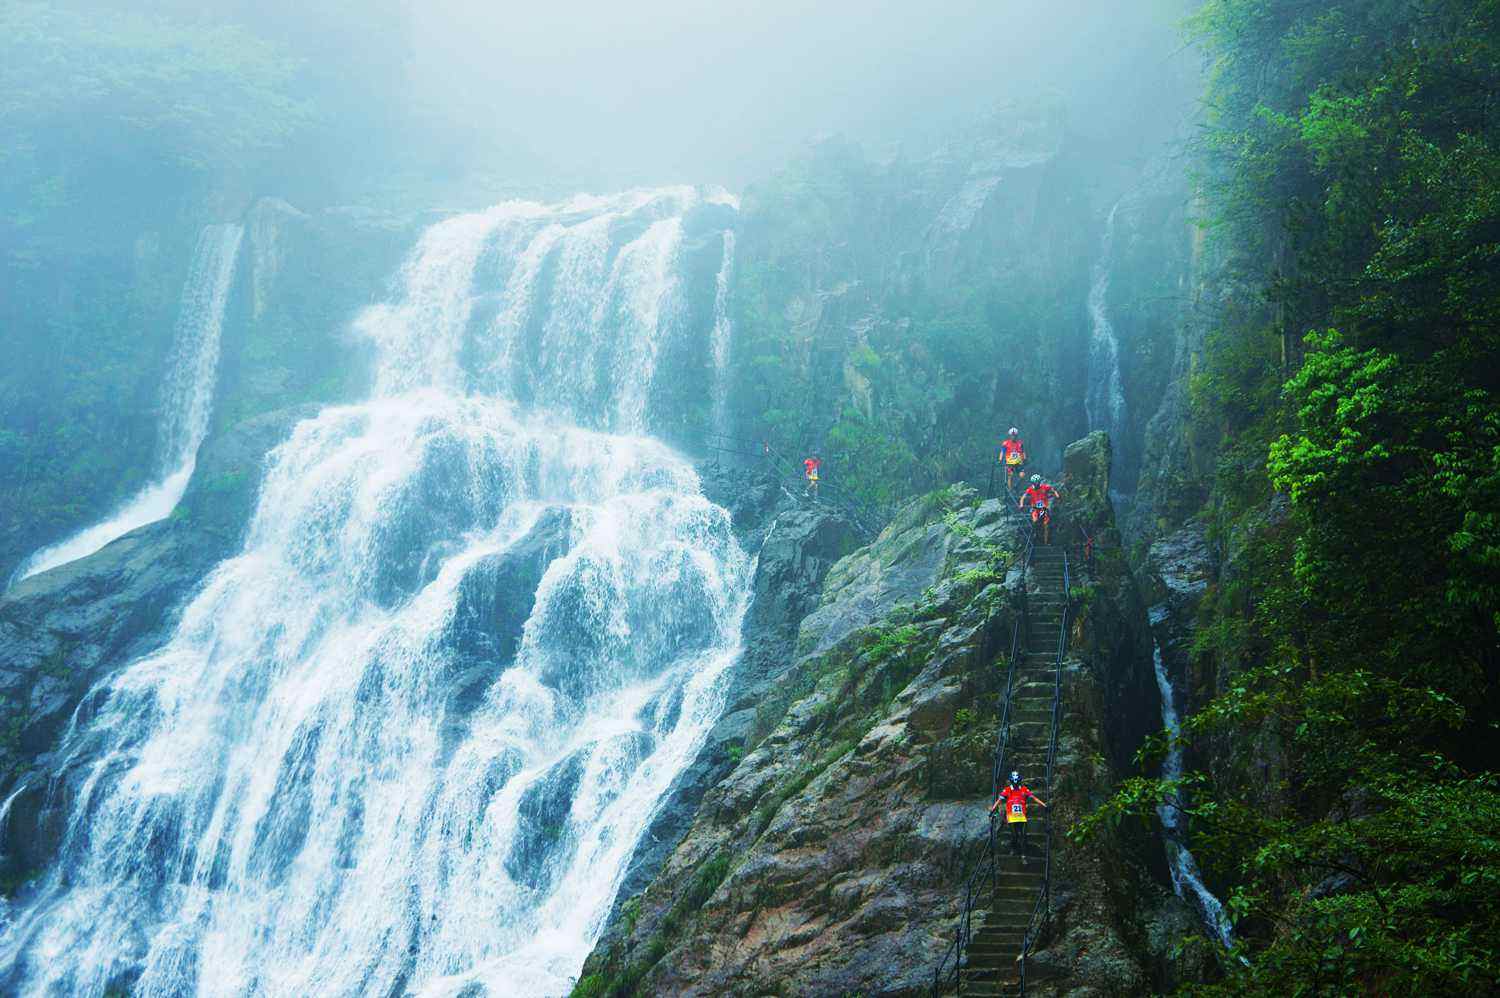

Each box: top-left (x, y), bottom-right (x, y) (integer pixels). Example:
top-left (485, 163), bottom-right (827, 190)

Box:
top-left (963, 543), bottom-right (1067, 995)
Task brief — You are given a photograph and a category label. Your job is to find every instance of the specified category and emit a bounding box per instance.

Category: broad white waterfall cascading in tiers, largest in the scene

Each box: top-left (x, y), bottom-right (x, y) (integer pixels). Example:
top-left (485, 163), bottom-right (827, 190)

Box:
top-left (0, 189), bottom-right (752, 998)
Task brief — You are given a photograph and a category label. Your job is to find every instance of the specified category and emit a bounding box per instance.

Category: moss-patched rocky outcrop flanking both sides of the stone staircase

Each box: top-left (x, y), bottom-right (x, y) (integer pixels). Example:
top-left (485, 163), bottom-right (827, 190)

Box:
top-left (575, 441), bottom-right (1163, 995)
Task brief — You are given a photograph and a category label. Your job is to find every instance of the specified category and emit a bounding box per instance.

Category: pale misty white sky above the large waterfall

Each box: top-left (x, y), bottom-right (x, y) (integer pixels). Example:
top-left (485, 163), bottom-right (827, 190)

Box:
top-left (413, 0), bottom-right (1185, 188)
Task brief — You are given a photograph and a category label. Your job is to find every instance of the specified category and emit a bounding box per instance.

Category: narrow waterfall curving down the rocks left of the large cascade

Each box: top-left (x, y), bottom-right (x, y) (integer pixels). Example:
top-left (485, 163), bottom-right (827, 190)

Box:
top-left (15, 225), bottom-right (245, 581)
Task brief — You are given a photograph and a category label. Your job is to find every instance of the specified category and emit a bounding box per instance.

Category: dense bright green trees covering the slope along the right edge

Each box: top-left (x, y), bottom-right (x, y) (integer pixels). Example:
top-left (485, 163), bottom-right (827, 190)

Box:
top-left (1098, 0), bottom-right (1500, 995)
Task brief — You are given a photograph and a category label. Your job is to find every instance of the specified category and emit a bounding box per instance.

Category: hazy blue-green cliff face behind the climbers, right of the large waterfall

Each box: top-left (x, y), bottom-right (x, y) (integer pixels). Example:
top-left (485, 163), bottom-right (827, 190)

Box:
top-left (720, 104), bottom-right (1196, 507)
